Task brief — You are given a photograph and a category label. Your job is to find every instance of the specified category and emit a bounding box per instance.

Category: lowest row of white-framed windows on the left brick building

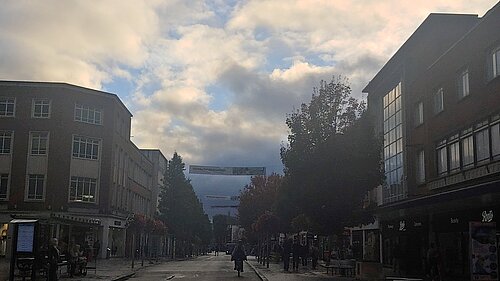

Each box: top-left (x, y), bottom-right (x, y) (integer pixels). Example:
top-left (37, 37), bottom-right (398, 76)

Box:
top-left (0, 174), bottom-right (97, 203)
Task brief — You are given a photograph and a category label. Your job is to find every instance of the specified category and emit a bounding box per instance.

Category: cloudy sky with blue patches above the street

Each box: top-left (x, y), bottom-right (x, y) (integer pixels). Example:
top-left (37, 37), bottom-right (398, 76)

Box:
top-left (0, 0), bottom-right (497, 215)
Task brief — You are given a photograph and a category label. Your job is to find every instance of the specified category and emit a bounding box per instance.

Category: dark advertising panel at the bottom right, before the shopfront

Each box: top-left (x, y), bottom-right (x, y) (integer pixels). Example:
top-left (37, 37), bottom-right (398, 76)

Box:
top-left (469, 222), bottom-right (498, 281)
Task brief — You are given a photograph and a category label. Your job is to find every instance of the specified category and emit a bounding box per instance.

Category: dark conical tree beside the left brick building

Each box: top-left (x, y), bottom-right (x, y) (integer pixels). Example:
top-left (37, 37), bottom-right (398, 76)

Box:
top-left (159, 153), bottom-right (212, 244)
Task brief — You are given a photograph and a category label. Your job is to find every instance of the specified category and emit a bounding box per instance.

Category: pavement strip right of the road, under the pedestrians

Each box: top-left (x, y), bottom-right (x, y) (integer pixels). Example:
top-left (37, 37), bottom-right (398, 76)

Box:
top-left (247, 256), bottom-right (355, 281)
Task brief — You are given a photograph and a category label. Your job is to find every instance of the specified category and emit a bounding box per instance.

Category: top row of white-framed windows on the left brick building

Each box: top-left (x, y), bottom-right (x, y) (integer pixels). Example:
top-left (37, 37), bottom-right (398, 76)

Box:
top-left (0, 97), bottom-right (102, 125)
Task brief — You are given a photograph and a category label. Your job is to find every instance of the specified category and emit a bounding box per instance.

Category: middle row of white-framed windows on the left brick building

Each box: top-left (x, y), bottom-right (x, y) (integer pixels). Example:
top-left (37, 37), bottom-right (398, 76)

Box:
top-left (0, 131), bottom-right (101, 160)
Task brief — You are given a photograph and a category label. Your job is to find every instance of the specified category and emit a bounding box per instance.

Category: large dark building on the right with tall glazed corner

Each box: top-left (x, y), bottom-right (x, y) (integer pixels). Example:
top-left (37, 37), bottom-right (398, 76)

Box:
top-left (364, 4), bottom-right (500, 280)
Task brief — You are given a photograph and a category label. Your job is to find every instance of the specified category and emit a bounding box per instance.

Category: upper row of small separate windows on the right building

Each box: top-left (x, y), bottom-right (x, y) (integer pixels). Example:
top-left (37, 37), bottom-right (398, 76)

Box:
top-left (413, 47), bottom-right (500, 126)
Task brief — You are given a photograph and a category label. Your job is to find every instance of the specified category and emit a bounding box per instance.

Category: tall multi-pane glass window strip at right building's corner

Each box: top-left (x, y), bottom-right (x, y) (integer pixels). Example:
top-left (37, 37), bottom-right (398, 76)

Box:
top-left (383, 84), bottom-right (406, 203)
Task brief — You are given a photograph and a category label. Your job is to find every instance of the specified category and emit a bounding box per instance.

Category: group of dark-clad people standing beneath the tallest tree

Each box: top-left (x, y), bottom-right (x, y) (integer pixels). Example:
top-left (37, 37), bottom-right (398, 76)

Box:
top-left (281, 236), bottom-right (319, 271)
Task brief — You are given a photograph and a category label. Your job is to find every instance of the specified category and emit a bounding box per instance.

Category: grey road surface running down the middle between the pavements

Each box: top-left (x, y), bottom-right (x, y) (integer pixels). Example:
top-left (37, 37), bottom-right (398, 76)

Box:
top-left (130, 253), bottom-right (260, 281)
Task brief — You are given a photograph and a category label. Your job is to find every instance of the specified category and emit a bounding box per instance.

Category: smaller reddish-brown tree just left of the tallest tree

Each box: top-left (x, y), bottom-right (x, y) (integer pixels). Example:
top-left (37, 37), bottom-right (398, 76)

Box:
top-left (238, 174), bottom-right (283, 236)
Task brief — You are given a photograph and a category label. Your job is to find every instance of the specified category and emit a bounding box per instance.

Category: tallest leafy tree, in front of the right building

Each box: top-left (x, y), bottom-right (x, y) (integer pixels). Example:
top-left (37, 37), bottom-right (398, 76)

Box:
top-left (277, 77), bottom-right (383, 234)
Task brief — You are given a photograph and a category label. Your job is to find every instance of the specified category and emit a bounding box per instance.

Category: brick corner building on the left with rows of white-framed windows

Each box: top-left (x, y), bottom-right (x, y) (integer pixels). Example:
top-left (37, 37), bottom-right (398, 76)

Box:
top-left (0, 81), bottom-right (158, 264)
